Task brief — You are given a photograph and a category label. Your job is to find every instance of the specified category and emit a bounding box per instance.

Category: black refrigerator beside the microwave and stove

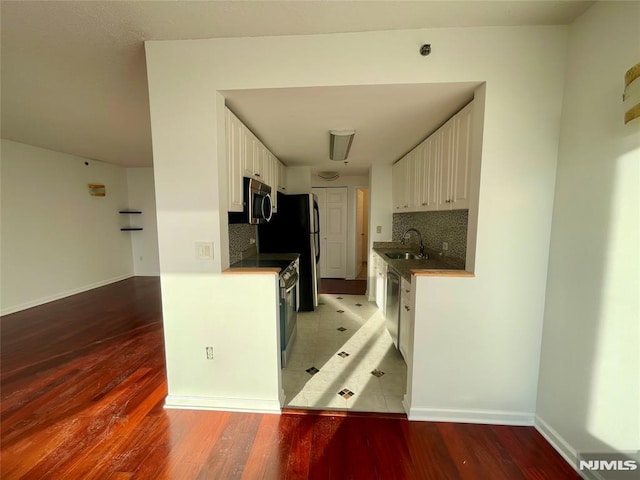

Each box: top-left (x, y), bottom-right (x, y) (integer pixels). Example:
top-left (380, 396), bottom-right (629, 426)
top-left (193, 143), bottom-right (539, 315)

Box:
top-left (258, 192), bottom-right (320, 312)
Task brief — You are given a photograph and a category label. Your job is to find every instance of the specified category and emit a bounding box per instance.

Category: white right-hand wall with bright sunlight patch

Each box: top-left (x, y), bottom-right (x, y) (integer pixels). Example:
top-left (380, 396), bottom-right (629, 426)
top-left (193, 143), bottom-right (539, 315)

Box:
top-left (537, 2), bottom-right (640, 461)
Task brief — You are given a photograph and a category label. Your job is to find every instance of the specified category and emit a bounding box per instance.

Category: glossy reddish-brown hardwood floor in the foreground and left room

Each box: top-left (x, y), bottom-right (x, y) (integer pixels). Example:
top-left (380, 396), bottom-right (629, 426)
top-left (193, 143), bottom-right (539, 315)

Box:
top-left (0, 277), bottom-right (579, 480)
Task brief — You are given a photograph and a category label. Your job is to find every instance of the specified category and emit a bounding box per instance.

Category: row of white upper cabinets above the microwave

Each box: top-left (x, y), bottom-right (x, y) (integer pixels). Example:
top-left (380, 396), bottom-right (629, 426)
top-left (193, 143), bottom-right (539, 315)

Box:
top-left (225, 108), bottom-right (286, 212)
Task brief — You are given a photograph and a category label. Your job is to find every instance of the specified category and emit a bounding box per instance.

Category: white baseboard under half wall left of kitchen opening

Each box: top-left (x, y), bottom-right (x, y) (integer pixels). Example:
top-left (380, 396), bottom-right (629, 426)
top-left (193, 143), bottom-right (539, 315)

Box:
top-left (164, 395), bottom-right (281, 414)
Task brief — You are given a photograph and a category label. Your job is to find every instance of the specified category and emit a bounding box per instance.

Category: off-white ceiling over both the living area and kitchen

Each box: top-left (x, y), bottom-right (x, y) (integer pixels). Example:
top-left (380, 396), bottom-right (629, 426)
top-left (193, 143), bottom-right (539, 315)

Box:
top-left (0, 0), bottom-right (593, 173)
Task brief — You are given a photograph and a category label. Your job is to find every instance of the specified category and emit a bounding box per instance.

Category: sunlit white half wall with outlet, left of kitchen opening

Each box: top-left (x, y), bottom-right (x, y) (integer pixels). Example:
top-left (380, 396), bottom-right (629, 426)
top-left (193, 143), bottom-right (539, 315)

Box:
top-left (161, 273), bottom-right (283, 412)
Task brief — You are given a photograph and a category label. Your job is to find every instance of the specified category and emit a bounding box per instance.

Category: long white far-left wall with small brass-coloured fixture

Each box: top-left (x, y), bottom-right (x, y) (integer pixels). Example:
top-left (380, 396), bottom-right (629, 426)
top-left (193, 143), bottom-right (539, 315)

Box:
top-left (1, 140), bottom-right (133, 314)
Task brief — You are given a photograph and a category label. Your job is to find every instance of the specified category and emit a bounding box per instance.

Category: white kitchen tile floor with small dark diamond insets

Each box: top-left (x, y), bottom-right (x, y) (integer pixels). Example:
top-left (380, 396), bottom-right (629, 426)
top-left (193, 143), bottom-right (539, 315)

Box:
top-left (282, 294), bottom-right (407, 413)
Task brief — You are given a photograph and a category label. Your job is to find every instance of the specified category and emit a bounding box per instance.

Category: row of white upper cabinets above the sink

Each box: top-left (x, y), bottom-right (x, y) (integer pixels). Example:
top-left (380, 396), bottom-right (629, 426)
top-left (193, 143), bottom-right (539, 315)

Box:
top-left (393, 102), bottom-right (473, 213)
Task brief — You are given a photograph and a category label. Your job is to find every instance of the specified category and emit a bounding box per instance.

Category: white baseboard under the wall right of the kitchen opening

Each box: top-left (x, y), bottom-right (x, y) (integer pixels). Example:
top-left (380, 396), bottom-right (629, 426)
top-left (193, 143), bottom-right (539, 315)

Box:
top-left (403, 402), bottom-right (534, 426)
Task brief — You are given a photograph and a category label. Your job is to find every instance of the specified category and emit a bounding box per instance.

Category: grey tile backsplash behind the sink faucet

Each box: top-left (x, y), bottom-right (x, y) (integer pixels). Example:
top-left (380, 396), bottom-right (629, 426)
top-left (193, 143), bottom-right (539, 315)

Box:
top-left (392, 210), bottom-right (469, 262)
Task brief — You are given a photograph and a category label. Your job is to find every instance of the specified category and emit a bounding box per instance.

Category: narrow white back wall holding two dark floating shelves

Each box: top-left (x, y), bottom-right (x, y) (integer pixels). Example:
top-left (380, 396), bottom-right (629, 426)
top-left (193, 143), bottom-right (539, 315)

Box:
top-left (127, 168), bottom-right (160, 276)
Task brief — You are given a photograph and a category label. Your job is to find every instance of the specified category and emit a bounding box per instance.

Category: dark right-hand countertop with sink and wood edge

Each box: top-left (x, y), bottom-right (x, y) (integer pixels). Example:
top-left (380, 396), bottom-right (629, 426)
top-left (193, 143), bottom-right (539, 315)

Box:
top-left (373, 242), bottom-right (473, 282)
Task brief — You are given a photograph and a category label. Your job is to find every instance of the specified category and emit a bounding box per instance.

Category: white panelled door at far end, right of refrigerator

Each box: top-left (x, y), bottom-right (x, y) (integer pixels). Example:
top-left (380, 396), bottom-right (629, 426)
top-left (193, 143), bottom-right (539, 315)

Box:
top-left (313, 187), bottom-right (347, 278)
